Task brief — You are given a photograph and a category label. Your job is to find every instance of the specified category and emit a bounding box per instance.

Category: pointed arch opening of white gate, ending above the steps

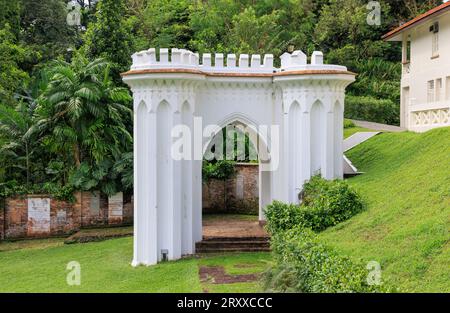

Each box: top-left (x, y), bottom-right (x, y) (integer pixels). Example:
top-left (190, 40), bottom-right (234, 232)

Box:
top-left (202, 115), bottom-right (271, 235)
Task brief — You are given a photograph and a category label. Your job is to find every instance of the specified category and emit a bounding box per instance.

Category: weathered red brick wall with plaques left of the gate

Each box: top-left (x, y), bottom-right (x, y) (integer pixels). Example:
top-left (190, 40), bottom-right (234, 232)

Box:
top-left (0, 192), bottom-right (133, 240)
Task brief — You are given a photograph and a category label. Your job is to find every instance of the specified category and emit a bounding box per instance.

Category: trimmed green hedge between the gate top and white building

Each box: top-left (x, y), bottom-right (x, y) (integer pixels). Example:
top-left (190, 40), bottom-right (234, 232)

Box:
top-left (344, 95), bottom-right (400, 125)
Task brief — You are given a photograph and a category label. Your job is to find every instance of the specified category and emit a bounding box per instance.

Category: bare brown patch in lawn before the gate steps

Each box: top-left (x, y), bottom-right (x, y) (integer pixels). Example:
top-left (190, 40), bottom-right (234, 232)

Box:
top-left (198, 266), bottom-right (259, 284)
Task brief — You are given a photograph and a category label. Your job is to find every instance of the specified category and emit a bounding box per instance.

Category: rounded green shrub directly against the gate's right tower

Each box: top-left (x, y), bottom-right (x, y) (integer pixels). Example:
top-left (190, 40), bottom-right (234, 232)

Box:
top-left (265, 176), bottom-right (364, 234)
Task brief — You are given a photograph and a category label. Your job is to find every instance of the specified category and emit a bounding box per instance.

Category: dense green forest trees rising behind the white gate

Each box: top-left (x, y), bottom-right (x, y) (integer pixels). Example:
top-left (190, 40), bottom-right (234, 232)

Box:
top-left (0, 0), bottom-right (440, 193)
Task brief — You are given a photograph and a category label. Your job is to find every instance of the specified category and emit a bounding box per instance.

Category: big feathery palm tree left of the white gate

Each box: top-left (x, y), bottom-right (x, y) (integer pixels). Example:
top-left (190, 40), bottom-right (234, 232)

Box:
top-left (28, 56), bottom-right (132, 193)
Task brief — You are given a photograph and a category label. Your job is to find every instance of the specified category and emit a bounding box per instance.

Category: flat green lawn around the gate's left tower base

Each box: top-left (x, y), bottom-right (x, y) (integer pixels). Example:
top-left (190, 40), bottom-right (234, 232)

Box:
top-left (0, 237), bottom-right (270, 292)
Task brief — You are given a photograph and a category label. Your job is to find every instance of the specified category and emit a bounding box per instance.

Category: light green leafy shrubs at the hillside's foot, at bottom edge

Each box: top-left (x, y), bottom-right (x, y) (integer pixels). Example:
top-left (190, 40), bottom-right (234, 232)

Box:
top-left (263, 226), bottom-right (390, 292)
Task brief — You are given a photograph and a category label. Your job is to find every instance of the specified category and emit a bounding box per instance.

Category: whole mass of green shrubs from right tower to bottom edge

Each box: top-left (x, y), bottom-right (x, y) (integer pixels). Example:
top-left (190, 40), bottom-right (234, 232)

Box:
top-left (263, 176), bottom-right (389, 292)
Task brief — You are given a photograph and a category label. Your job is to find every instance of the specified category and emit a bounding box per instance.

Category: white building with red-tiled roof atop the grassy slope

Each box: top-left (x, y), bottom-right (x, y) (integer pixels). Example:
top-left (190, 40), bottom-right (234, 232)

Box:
top-left (383, 2), bottom-right (450, 132)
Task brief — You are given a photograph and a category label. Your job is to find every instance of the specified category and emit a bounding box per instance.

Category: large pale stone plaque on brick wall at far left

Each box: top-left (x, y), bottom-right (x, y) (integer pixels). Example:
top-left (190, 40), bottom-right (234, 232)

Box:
top-left (28, 198), bottom-right (50, 234)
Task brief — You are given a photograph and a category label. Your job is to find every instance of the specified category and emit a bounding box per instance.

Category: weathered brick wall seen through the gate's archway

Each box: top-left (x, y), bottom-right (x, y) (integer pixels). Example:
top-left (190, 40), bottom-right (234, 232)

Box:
top-left (202, 163), bottom-right (259, 214)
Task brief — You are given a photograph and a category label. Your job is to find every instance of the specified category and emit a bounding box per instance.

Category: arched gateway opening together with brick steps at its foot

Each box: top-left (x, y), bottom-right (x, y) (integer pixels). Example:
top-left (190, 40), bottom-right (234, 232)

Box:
top-left (200, 122), bottom-right (271, 246)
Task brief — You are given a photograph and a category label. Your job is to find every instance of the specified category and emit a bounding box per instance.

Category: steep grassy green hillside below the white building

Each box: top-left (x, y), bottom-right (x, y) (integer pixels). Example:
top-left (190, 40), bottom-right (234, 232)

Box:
top-left (321, 128), bottom-right (450, 292)
